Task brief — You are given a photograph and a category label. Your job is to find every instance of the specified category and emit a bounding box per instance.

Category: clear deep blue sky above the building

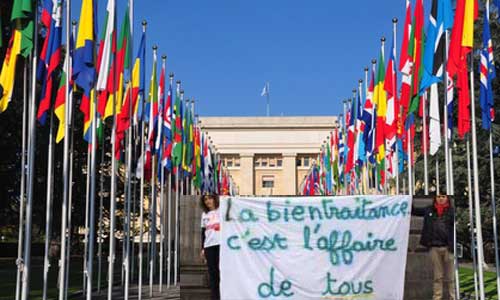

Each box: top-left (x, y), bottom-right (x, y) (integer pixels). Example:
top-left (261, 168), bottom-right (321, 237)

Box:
top-left (72, 0), bottom-right (438, 116)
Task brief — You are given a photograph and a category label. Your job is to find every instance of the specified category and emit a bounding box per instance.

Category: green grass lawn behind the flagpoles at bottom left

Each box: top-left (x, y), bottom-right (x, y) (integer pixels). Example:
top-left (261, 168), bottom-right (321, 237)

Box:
top-left (0, 258), bottom-right (109, 300)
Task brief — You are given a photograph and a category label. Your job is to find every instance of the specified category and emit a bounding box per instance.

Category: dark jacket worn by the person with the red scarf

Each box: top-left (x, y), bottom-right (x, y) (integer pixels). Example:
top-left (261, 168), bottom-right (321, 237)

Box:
top-left (411, 205), bottom-right (455, 252)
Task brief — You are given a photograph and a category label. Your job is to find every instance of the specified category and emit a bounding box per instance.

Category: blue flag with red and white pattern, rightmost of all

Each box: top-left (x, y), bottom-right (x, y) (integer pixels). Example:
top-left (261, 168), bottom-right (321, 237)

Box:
top-left (479, 4), bottom-right (496, 130)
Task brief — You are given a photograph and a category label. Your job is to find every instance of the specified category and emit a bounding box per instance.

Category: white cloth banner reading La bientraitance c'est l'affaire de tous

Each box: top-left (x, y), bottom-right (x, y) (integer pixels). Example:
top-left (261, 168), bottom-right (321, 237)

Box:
top-left (220, 196), bottom-right (411, 300)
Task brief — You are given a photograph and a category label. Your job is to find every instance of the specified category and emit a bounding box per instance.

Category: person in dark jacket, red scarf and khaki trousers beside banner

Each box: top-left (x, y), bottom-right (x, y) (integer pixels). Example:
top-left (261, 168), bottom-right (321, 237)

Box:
top-left (412, 195), bottom-right (455, 300)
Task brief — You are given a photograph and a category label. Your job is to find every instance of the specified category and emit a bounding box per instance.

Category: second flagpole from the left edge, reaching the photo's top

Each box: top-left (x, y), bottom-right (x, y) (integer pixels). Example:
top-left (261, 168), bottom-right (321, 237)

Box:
top-left (21, 0), bottom-right (38, 300)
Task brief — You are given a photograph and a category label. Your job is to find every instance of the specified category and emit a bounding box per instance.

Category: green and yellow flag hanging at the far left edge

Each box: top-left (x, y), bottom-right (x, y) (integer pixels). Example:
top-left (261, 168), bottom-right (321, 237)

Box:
top-left (0, 0), bottom-right (34, 113)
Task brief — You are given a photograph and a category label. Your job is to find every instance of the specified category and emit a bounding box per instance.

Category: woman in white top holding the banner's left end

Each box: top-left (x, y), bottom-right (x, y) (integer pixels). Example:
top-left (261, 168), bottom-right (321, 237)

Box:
top-left (200, 195), bottom-right (220, 300)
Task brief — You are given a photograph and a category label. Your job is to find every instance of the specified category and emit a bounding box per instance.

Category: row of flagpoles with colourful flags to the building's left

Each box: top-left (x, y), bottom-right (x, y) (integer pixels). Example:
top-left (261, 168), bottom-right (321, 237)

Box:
top-left (0, 0), bottom-right (239, 300)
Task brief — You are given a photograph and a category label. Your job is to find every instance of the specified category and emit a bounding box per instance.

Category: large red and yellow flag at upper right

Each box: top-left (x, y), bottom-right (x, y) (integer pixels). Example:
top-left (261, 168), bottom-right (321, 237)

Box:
top-left (446, 0), bottom-right (477, 138)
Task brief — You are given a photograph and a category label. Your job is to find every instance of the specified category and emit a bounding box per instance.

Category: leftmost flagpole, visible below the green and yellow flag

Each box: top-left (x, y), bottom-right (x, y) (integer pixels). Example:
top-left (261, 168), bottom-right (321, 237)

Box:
top-left (16, 60), bottom-right (28, 300)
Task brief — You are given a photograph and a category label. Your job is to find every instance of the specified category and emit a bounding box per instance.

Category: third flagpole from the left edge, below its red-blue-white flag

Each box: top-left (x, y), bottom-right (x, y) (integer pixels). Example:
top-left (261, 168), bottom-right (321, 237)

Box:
top-left (42, 109), bottom-right (54, 300)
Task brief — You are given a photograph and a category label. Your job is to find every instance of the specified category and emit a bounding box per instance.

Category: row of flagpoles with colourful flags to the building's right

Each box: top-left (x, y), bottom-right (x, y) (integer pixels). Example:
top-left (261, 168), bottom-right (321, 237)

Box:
top-left (302, 0), bottom-right (500, 300)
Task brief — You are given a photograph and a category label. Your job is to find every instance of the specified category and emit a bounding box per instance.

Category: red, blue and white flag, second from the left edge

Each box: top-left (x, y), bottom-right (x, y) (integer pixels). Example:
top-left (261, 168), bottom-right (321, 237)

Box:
top-left (37, 0), bottom-right (63, 124)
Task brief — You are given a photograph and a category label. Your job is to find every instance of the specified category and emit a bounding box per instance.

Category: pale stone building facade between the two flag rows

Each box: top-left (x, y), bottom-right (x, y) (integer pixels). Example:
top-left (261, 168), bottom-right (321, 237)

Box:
top-left (200, 116), bottom-right (337, 196)
